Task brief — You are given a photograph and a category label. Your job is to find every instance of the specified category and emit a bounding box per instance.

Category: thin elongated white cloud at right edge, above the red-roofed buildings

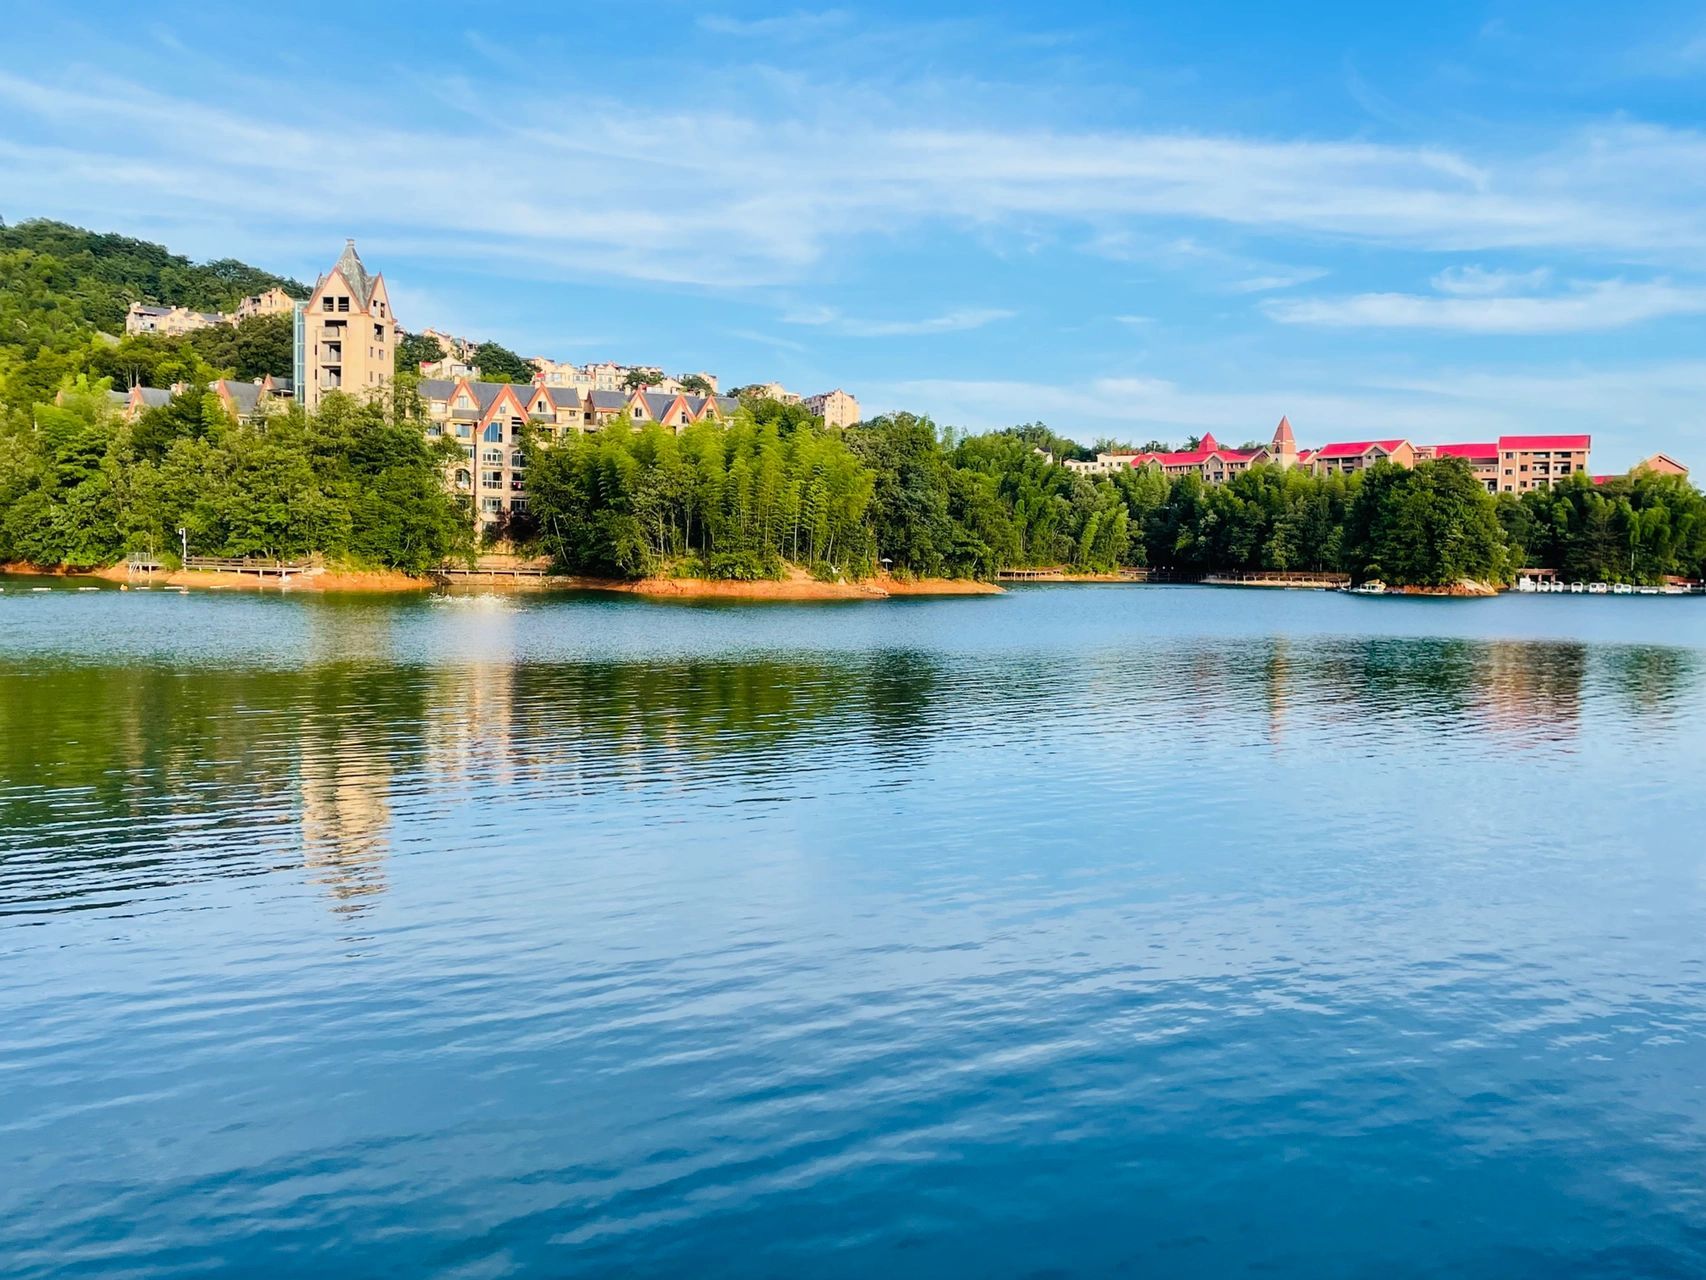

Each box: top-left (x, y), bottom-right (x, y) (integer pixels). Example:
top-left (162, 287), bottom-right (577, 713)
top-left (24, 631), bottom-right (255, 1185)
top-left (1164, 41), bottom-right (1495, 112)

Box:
top-left (1262, 280), bottom-right (1706, 333)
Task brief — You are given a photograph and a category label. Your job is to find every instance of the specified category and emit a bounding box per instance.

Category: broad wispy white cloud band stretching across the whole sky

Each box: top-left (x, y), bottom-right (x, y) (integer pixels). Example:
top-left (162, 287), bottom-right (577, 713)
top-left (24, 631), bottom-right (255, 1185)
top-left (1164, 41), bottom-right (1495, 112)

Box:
top-left (10, 68), bottom-right (1706, 292)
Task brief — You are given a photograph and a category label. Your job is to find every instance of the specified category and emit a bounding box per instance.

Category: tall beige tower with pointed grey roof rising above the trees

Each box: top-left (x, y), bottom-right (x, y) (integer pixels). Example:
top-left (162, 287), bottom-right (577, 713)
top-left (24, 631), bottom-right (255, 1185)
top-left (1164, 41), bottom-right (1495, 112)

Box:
top-left (295, 241), bottom-right (399, 410)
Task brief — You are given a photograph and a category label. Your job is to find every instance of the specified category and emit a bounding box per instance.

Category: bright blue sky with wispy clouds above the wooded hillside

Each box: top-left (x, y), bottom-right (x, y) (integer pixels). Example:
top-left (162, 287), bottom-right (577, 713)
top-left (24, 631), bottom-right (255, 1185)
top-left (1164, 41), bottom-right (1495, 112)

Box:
top-left (0, 0), bottom-right (1706, 469)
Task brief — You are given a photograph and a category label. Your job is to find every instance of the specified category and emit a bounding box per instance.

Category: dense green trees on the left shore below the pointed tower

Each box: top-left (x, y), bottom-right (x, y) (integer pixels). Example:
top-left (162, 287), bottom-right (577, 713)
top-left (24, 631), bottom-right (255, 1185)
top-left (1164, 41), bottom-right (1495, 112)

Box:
top-left (0, 379), bottom-right (467, 572)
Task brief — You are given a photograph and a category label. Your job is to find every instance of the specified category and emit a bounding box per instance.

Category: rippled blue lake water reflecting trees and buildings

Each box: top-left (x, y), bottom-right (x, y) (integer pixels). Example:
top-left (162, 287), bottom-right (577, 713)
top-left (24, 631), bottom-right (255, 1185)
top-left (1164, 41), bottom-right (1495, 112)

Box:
top-left (0, 579), bottom-right (1706, 1277)
